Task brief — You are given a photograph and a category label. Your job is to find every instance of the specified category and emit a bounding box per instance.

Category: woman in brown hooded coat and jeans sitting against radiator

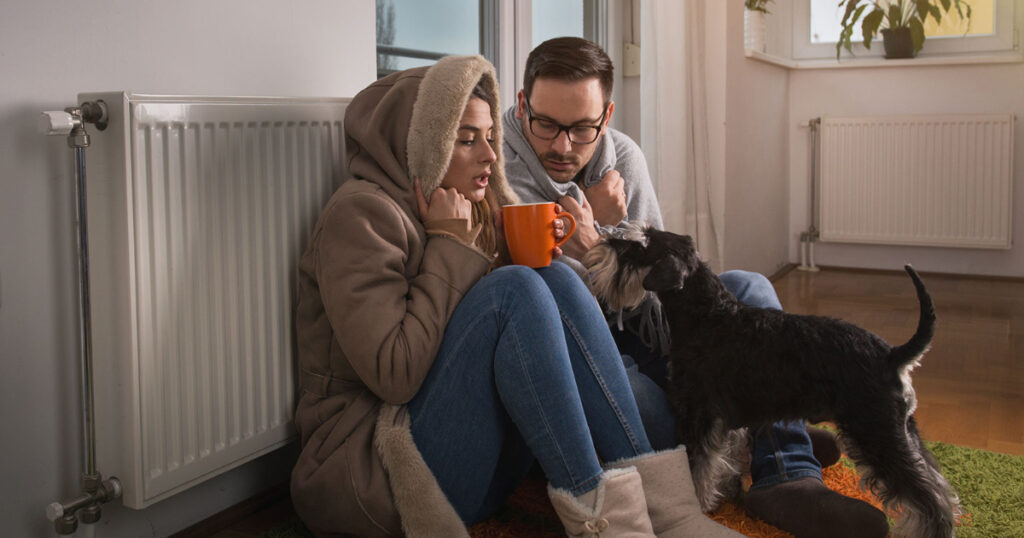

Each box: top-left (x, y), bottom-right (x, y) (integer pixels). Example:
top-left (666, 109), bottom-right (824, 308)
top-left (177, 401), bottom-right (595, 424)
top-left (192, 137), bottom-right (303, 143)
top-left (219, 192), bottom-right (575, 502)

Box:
top-left (292, 56), bottom-right (737, 536)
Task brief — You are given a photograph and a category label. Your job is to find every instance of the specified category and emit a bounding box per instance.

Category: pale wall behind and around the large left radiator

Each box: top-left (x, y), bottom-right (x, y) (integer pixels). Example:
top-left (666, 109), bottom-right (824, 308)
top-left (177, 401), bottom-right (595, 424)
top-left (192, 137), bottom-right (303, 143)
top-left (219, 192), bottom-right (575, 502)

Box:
top-left (0, 0), bottom-right (376, 537)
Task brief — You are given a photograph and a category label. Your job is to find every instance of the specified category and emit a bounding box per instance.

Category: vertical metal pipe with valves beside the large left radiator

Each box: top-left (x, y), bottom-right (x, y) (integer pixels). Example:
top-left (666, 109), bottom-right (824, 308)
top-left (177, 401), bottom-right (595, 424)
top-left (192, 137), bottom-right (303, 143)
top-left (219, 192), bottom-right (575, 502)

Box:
top-left (43, 101), bottom-right (121, 535)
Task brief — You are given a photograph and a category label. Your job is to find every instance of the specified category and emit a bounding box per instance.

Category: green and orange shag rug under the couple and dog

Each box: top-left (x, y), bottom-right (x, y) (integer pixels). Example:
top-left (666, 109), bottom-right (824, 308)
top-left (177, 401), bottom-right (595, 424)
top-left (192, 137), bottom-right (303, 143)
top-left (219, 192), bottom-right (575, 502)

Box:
top-left (262, 443), bottom-right (1024, 538)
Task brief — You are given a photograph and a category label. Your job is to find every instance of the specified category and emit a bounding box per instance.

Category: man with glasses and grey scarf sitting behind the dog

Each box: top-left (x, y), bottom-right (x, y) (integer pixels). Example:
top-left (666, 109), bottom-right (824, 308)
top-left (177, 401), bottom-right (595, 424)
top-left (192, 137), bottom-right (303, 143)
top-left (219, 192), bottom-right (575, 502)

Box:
top-left (503, 38), bottom-right (889, 537)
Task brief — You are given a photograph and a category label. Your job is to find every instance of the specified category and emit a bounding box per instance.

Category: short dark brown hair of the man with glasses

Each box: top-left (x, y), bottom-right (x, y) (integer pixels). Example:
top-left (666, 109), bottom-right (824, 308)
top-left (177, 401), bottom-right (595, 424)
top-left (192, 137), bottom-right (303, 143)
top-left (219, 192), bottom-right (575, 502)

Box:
top-left (522, 37), bottom-right (614, 104)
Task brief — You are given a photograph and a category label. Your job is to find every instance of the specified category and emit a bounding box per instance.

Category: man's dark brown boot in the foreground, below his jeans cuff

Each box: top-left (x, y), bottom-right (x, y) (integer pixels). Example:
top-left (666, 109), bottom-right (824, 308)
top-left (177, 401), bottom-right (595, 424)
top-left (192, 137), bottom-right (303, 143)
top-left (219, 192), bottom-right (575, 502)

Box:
top-left (744, 477), bottom-right (889, 538)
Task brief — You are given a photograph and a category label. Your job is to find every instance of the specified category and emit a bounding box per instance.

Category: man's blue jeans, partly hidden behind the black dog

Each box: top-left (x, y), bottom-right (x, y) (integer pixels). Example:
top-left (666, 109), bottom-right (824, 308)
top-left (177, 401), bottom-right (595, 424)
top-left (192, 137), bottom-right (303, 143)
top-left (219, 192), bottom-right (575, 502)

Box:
top-left (615, 271), bottom-right (821, 489)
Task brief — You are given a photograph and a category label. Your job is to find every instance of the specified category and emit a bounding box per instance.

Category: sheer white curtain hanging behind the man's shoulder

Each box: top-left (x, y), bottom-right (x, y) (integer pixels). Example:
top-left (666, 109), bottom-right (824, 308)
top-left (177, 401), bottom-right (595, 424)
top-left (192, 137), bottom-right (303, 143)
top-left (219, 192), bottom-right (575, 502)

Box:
top-left (640, 0), bottom-right (724, 271)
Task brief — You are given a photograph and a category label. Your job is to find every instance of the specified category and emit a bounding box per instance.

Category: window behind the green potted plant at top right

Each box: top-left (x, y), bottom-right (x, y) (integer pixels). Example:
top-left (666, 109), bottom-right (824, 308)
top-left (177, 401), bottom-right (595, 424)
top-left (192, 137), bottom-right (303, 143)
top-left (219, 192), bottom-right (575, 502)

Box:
top-left (793, 0), bottom-right (1016, 58)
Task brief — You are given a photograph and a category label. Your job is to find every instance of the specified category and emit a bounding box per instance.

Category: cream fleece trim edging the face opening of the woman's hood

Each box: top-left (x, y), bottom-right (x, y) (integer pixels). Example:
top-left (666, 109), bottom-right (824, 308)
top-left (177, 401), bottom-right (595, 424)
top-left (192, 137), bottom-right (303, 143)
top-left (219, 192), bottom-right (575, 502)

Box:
top-left (407, 55), bottom-right (518, 204)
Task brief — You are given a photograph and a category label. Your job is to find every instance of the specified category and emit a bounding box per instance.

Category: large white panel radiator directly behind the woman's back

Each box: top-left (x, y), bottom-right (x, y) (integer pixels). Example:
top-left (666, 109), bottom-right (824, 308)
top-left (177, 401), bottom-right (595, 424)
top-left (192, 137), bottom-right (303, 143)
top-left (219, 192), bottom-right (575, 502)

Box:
top-left (79, 93), bottom-right (348, 508)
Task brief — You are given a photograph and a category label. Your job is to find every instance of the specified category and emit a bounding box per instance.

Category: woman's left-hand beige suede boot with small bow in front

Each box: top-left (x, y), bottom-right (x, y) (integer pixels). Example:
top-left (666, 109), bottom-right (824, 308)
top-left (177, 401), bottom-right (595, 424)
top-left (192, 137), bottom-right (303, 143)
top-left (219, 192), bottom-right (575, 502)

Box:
top-left (548, 467), bottom-right (654, 538)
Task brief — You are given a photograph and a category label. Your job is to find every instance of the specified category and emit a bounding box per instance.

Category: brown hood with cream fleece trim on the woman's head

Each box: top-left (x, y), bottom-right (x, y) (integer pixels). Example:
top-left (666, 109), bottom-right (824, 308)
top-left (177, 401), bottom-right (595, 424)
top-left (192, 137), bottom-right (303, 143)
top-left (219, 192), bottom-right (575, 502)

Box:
top-left (345, 55), bottom-right (518, 215)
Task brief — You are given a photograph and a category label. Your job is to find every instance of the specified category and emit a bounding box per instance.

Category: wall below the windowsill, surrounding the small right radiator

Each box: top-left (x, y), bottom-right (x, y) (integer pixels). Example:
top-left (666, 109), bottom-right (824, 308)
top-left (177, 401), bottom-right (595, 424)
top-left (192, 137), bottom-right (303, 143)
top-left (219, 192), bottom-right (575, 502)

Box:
top-left (787, 60), bottom-right (1024, 277)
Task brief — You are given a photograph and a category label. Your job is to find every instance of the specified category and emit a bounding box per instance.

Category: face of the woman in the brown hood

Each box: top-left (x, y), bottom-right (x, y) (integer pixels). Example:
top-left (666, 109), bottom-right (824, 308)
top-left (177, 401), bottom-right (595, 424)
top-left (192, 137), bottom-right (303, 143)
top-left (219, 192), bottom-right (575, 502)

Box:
top-left (441, 97), bottom-right (498, 202)
